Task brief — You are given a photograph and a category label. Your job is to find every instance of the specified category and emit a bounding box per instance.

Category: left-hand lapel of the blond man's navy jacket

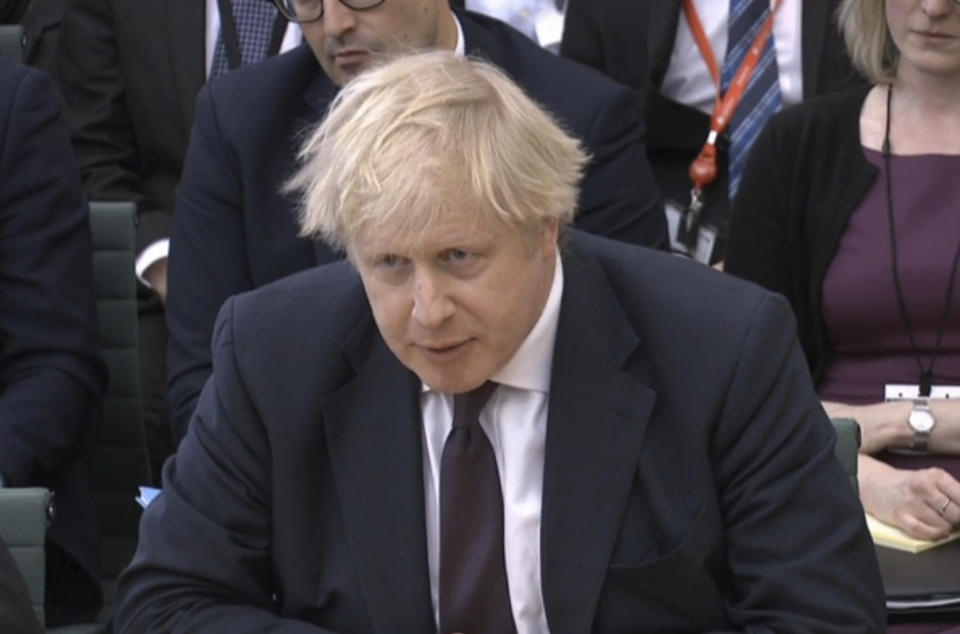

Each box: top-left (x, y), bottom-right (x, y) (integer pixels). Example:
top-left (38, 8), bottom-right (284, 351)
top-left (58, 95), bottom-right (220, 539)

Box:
top-left (323, 313), bottom-right (435, 633)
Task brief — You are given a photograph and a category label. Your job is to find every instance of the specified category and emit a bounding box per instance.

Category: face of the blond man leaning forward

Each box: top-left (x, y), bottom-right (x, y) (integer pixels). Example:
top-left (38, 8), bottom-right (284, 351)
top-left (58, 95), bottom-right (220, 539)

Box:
top-left (350, 210), bottom-right (557, 394)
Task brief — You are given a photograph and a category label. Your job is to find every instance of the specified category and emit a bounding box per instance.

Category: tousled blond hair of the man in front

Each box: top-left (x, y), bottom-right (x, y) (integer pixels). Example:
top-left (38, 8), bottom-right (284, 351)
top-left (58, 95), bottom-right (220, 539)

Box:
top-left (284, 51), bottom-right (588, 251)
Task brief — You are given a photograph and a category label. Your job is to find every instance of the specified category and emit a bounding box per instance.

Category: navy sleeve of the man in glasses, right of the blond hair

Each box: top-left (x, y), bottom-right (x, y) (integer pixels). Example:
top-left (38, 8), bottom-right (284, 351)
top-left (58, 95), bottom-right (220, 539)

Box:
top-left (575, 82), bottom-right (669, 249)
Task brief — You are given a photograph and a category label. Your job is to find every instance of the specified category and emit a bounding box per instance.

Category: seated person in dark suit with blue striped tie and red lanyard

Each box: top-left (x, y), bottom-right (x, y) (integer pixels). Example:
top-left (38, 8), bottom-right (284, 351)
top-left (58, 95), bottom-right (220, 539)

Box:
top-left (560, 0), bottom-right (862, 263)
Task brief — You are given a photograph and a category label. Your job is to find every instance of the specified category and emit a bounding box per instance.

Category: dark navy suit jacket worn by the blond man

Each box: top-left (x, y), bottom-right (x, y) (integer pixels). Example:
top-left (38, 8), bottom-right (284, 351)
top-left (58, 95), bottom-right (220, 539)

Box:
top-left (117, 232), bottom-right (884, 634)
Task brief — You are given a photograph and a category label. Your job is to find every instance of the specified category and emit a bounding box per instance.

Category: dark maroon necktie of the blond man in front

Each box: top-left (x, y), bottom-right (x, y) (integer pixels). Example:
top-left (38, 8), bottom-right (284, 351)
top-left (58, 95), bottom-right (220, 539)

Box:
top-left (439, 381), bottom-right (517, 634)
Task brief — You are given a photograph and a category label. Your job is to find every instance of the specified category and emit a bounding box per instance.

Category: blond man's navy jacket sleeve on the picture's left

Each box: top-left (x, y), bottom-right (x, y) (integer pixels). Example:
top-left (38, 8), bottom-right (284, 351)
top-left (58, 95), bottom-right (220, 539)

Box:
top-left (116, 300), bottom-right (336, 634)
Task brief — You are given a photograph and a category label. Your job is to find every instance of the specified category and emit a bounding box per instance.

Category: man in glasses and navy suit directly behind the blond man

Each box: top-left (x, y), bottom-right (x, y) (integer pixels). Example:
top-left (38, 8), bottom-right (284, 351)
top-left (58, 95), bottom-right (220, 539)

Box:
top-left (168, 0), bottom-right (666, 438)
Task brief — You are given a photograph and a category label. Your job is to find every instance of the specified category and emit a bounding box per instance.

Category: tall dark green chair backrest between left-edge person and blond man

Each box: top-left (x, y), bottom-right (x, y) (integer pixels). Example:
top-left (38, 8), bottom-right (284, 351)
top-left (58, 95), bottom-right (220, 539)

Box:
top-left (88, 202), bottom-right (147, 607)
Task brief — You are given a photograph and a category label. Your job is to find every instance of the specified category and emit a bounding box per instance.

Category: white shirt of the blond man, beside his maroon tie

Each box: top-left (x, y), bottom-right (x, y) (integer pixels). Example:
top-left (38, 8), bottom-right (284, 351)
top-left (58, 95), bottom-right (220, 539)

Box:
top-left (420, 249), bottom-right (563, 634)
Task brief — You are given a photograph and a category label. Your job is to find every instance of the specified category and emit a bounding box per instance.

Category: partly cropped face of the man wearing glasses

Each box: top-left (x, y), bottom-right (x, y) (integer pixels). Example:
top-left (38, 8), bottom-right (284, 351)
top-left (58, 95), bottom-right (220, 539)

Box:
top-left (301, 0), bottom-right (456, 86)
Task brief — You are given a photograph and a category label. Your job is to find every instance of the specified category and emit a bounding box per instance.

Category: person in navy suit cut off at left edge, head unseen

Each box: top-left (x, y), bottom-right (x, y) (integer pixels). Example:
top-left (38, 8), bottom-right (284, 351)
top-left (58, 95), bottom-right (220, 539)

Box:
top-left (0, 58), bottom-right (106, 625)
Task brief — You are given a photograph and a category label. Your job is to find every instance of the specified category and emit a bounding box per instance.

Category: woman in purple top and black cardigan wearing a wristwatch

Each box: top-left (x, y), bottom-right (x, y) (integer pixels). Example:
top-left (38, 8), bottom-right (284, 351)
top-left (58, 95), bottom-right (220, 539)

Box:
top-left (727, 0), bottom-right (960, 539)
